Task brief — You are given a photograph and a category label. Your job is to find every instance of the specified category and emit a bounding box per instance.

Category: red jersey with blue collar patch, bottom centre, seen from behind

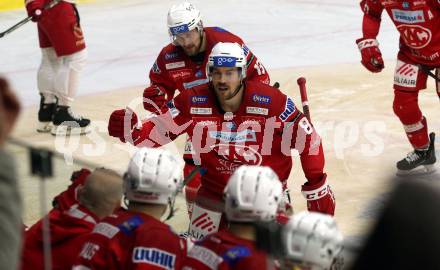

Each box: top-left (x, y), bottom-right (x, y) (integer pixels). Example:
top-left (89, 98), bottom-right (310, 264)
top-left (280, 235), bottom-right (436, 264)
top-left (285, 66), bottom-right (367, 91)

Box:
top-left (182, 230), bottom-right (275, 270)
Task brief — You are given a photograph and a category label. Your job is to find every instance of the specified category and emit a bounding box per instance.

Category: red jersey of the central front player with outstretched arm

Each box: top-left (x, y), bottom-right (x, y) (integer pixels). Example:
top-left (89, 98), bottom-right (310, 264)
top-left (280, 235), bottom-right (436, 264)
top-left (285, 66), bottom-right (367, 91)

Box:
top-left (134, 81), bottom-right (324, 197)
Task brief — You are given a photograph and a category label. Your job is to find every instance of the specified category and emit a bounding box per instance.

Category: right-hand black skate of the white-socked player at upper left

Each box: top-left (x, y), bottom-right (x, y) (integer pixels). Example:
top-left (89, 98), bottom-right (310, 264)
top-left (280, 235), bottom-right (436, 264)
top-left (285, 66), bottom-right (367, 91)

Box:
top-left (51, 106), bottom-right (90, 136)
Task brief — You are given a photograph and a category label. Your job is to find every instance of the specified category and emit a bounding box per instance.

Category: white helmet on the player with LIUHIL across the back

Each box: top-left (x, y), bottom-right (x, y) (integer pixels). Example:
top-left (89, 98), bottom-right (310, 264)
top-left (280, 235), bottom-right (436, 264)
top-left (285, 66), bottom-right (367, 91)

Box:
top-left (124, 147), bottom-right (183, 204)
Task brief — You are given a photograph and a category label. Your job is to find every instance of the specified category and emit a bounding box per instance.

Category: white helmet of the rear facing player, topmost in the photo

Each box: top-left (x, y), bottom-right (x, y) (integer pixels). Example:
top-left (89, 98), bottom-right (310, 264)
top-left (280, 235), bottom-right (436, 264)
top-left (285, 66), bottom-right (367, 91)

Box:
top-left (167, 1), bottom-right (203, 43)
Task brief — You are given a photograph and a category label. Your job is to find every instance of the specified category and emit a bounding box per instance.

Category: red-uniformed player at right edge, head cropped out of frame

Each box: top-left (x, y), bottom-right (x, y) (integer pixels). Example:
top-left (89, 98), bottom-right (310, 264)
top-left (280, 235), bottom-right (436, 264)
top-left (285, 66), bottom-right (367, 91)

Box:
top-left (356, 0), bottom-right (440, 173)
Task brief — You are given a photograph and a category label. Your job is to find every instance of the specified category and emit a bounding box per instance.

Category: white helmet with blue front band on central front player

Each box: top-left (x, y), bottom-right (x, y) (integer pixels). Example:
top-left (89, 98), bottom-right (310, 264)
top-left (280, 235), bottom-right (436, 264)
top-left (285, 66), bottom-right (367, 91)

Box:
top-left (206, 42), bottom-right (247, 80)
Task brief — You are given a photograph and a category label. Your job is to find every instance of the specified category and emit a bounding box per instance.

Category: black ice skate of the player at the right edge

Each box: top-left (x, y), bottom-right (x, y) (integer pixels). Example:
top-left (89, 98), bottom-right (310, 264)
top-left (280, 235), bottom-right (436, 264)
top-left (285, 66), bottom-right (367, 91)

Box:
top-left (397, 132), bottom-right (436, 176)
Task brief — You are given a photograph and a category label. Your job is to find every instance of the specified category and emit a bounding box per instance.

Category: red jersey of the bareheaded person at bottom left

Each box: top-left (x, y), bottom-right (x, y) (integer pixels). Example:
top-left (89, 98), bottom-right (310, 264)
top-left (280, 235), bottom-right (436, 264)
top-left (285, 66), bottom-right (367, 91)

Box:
top-left (21, 204), bottom-right (98, 270)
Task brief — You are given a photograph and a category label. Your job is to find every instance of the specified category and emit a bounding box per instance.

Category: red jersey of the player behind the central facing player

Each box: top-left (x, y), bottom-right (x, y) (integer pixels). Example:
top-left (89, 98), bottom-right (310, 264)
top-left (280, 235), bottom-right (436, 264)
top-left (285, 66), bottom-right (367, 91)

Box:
top-left (150, 27), bottom-right (270, 100)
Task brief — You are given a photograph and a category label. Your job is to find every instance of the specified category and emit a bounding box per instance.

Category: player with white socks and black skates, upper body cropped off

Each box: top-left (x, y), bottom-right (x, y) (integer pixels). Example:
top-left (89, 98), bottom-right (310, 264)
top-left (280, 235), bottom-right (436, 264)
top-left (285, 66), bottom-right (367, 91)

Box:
top-left (25, 0), bottom-right (90, 135)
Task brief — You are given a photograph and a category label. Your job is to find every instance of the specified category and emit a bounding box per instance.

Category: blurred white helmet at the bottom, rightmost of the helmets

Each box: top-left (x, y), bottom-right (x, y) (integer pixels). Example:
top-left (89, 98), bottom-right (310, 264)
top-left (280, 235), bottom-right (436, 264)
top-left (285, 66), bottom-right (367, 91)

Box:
top-left (283, 211), bottom-right (343, 270)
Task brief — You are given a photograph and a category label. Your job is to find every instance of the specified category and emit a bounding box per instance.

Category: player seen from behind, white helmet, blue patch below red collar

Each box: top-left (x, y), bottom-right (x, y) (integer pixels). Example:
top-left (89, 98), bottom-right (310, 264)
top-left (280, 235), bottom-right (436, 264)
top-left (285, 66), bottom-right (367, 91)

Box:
top-left (182, 165), bottom-right (283, 270)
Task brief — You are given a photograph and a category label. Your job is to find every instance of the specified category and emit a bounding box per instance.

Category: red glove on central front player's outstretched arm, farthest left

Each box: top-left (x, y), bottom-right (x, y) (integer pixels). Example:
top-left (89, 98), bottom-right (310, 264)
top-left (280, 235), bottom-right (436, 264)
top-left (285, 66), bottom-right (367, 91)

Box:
top-left (108, 109), bottom-right (138, 142)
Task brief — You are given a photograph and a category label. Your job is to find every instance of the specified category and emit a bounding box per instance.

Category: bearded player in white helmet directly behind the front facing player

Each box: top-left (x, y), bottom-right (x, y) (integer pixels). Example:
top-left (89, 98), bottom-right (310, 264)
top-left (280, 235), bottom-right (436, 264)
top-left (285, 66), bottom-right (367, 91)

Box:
top-left (143, 2), bottom-right (270, 219)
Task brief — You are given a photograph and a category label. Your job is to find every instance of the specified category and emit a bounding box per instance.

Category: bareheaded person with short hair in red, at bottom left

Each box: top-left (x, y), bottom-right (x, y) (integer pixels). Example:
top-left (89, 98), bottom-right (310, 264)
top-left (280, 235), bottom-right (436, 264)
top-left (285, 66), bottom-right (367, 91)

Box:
top-left (21, 169), bottom-right (122, 270)
